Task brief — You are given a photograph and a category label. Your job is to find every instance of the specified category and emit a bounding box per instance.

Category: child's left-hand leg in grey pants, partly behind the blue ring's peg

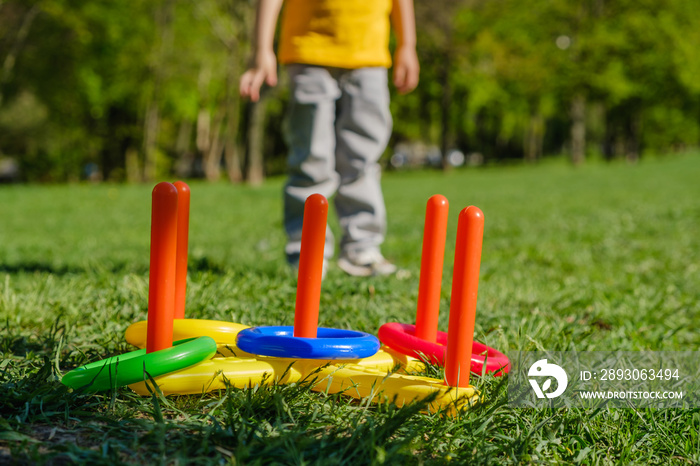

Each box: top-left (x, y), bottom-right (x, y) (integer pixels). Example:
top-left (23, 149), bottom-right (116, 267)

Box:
top-left (284, 65), bottom-right (340, 263)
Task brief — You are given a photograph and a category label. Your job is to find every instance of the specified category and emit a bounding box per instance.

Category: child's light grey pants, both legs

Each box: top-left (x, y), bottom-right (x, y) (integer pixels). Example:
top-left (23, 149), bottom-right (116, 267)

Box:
top-left (284, 65), bottom-right (392, 261)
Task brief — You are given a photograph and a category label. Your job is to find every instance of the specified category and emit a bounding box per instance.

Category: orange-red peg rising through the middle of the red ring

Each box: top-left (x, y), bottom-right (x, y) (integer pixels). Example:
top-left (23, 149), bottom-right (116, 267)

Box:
top-left (416, 194), bottom-right (450, 343)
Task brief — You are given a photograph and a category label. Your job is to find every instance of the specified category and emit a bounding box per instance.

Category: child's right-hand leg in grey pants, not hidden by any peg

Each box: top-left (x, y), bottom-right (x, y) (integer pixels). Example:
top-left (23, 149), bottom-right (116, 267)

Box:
top-left (335, 68), bottom-right (392, 255)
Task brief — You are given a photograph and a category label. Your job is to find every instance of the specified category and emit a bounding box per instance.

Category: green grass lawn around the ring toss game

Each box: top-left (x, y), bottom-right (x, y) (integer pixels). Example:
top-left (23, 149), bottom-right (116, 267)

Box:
top-left (0, 154), bottom-right (700, 465)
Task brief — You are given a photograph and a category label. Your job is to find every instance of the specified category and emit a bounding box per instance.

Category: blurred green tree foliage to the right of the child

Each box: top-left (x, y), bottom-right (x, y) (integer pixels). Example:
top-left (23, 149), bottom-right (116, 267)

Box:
top-left (408, 0), bottom-right (700, 162)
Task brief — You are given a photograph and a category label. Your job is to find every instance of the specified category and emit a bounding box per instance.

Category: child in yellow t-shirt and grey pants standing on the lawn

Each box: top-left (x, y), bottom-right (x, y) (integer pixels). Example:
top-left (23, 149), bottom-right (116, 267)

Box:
top-left (240, 0), bottom-right (419, 276)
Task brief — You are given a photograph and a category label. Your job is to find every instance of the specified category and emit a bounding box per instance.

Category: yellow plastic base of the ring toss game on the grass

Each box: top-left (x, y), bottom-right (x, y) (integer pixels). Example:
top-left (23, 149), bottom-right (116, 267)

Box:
top-left (126, 319), bottom-right (479, 413)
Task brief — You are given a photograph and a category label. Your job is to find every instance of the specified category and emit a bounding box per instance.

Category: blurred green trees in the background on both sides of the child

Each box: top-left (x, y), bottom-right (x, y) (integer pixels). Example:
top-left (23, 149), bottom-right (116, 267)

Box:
top-left (0, 0), bottom-right (700, 181)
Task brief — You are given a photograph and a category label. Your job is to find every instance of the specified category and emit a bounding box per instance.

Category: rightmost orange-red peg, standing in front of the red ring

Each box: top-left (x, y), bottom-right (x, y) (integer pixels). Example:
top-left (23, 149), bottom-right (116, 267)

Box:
top-left (445, 206), bottom-right (484, 387)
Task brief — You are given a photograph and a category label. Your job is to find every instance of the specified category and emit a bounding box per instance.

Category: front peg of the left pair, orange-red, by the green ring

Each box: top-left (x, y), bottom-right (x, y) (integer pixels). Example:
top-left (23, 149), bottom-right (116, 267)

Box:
top-left (146, 182), bottom-right (177, 353)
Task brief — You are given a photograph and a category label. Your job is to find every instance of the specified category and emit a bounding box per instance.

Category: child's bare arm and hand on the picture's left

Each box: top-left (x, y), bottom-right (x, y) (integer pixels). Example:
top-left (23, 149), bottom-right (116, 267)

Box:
top-left (240, 0), bottom-right (283, 102)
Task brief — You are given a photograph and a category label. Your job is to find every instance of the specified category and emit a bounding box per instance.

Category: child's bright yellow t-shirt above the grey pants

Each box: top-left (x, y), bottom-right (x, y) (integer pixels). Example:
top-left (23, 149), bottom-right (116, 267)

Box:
top-left (279, 0), bottom-right (392, 69)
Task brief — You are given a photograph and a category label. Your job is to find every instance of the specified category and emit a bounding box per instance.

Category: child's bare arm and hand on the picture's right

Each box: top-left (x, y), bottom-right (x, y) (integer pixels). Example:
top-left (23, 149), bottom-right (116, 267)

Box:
top-left (391, 0), bottom-right (420, 94)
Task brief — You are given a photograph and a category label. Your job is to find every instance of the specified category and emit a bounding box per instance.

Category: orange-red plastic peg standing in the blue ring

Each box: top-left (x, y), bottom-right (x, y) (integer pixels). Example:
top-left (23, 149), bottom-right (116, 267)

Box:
top-left (294, 194), bottom-right (328, 338)
